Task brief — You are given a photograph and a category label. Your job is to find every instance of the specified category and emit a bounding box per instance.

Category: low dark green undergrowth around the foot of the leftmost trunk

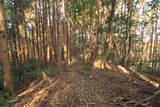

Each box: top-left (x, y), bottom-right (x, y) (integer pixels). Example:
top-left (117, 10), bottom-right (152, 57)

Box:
top-left (0, 64), bottom-right (54, 107)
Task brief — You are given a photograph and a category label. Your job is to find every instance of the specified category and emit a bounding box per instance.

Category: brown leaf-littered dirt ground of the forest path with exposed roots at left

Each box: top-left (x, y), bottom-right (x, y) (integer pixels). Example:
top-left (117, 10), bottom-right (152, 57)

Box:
top-left (14, 58), bottom-right (160, 107)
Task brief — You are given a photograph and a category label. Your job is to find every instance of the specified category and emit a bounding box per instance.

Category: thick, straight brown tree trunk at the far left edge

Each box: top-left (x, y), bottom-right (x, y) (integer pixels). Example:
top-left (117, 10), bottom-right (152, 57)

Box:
top-left (0, 0), bottom-right (13, 93)
